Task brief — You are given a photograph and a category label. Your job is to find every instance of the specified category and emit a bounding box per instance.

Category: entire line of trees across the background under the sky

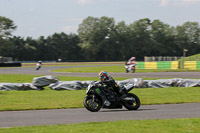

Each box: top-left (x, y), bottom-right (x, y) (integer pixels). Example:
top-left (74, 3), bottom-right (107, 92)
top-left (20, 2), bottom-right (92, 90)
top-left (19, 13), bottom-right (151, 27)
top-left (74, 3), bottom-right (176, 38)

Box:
top-left (0, 16), bottom-right (200, 61)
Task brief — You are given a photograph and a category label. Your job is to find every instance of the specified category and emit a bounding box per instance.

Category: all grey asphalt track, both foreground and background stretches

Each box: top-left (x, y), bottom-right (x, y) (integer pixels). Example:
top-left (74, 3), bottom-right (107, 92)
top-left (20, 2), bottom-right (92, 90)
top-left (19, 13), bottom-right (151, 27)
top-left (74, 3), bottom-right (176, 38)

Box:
top-left (0, 66), bottom-right (200, 127)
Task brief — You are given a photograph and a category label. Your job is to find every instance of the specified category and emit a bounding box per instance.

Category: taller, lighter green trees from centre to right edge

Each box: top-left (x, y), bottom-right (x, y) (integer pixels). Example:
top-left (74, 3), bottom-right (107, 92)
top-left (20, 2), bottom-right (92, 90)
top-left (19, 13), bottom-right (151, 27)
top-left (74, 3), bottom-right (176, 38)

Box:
top-left (78, 17), bottom-right (200, 61)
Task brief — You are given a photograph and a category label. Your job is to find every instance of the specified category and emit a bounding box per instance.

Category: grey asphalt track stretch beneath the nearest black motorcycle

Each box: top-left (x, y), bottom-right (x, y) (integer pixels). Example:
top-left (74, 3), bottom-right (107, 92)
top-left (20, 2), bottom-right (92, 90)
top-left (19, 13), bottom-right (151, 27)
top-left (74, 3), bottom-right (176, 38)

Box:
top-left (0, 103), bottom-right (200, 127)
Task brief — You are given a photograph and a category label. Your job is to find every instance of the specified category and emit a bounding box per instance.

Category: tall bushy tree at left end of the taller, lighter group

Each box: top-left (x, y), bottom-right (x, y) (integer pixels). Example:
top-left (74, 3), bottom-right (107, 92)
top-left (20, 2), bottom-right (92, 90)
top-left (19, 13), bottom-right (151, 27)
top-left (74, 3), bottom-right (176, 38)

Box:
top-left (78, 17), bottom-right (115, 61)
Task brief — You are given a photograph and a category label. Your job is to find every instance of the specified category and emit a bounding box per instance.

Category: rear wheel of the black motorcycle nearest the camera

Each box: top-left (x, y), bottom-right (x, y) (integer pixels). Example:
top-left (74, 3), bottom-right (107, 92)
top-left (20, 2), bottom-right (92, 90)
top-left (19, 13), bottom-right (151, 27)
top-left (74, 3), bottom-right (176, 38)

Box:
top-left (123, 93), bottom-right (140, 110)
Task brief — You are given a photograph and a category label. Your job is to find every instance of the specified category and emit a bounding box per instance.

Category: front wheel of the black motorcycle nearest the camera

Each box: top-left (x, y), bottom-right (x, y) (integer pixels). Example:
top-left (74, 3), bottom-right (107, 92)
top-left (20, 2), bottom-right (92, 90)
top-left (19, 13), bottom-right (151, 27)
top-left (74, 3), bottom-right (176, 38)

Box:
top-left (83, 96), bottom-right (102, 112)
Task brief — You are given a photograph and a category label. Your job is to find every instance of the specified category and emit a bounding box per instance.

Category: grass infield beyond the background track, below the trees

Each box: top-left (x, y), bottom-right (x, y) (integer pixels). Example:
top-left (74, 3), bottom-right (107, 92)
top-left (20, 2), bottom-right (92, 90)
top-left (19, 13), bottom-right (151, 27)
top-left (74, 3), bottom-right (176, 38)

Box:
top-left (22, 61), bottom-right (200, 73)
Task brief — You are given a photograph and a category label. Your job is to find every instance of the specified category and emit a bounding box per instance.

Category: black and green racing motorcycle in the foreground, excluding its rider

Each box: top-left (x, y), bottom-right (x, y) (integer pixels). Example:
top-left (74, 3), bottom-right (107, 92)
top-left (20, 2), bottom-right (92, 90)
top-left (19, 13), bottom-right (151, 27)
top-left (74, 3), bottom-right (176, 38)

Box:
top-left (83, 81), bottom-right (140, 112)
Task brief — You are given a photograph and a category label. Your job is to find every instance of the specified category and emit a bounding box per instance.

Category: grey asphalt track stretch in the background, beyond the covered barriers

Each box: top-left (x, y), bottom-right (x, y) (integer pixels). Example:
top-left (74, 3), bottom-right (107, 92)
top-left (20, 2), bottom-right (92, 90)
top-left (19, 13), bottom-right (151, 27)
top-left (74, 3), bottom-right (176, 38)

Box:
top-left (0, 66), bottom-right (200, 78)
